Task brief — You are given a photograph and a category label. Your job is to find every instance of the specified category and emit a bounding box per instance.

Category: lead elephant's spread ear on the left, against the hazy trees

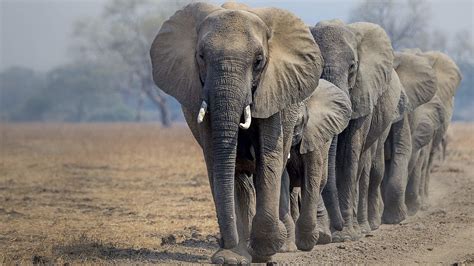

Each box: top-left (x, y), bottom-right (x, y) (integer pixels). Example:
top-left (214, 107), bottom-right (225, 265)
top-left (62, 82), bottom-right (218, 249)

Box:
top-left (150, 3), bottom-right (221, 108)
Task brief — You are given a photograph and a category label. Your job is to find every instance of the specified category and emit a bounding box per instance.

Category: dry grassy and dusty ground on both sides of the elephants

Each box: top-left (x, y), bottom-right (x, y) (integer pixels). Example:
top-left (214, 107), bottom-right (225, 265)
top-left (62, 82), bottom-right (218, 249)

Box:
top-left (0, 124), bottom-right (474, 264)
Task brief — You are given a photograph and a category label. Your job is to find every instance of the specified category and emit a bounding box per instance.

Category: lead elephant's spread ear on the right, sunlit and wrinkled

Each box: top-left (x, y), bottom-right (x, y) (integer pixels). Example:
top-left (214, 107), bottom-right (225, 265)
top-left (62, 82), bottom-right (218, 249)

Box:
top-left (247, 8), bottom-right (323, 118)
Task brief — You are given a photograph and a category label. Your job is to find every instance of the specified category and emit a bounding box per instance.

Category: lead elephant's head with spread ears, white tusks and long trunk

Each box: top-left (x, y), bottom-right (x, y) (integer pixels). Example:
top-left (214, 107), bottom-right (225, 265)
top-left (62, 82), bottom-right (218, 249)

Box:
top-left (150, 3), bottom-right (322, 249)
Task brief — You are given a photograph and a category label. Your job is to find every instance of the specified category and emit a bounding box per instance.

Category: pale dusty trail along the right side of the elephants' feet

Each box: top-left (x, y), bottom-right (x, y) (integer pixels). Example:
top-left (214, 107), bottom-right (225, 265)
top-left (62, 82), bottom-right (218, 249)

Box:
top-left (276, 158), bottom-right (474, 264)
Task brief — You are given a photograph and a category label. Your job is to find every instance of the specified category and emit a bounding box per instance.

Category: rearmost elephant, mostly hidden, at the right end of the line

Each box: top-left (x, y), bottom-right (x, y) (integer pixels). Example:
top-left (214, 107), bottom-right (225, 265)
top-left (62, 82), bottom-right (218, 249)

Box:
top-left (405, 50), bottom-right (462, 215)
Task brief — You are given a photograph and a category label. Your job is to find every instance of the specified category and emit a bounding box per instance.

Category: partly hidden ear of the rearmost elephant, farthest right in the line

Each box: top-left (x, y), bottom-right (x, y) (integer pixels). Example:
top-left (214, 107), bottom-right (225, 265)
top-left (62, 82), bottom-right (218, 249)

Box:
top-left (423, 51), bottom-right (462, 103)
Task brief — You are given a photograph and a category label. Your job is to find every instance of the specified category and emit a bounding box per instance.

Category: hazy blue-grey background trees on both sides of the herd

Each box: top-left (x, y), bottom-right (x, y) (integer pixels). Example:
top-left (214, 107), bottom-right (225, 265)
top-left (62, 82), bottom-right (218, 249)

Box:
top-left (0, 0), bottom-right (474, 122)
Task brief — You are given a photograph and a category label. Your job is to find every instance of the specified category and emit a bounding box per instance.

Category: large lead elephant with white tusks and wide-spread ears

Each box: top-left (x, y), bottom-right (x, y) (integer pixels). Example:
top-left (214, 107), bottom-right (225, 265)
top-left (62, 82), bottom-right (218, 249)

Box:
top-left (150, 2), bottom-right (323, 264)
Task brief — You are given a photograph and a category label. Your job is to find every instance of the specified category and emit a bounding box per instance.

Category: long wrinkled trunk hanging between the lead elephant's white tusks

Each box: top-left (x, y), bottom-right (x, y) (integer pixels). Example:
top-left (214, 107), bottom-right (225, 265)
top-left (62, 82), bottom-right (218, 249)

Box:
top-left (209, 74), bottom-right (250, 249)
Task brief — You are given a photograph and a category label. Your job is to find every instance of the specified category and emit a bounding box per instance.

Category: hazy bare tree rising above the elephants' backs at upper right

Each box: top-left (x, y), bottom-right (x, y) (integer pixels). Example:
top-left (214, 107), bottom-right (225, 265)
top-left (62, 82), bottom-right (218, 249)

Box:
top-left (350, 0), bottom-right (431, 49)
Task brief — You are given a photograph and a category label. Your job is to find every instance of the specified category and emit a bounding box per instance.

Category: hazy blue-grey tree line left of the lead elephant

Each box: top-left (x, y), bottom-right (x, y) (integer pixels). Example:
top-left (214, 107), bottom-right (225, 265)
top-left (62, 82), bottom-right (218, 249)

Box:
top-left (0, 0), bottom-right (190, 126)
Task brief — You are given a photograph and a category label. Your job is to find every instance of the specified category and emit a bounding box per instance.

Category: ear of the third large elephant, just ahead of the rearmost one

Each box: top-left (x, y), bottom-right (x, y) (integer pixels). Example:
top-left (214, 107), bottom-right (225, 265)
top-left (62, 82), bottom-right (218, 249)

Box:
top-left (394, 52), bottom-right (437, 112)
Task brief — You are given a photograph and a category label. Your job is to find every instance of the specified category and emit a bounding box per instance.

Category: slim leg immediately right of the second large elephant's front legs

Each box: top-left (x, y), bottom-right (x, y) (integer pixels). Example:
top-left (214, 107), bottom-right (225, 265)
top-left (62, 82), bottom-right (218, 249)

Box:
top-left (357, 145), bottom-right (377, 235)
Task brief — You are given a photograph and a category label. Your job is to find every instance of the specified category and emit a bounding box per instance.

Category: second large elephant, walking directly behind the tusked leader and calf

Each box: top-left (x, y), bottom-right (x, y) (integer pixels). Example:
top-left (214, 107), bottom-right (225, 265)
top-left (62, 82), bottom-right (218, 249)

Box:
top-left (311, 20), bottom-right (402, 242)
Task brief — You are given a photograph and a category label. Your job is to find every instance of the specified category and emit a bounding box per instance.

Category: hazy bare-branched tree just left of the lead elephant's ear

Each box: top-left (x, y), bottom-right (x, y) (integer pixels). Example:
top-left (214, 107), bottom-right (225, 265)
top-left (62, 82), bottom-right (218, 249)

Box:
top-left (73, 0), bottom-right (193, 126)
